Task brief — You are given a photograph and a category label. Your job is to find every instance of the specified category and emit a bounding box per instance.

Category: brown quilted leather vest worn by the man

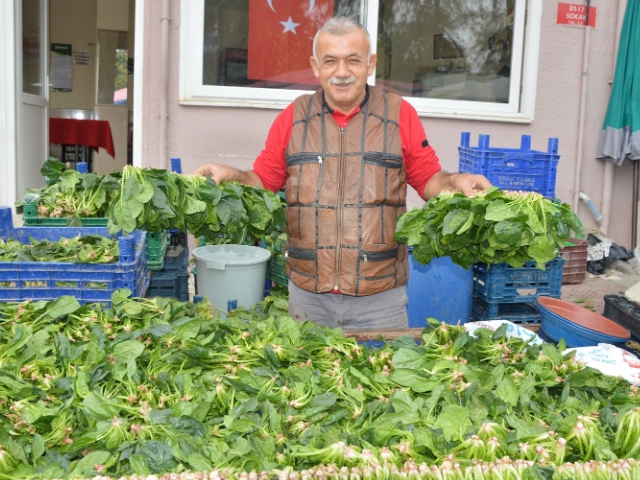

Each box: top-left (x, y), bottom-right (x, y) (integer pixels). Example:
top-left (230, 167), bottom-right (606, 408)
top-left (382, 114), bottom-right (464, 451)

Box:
top-left (285, 87), bottom-right (408, 296)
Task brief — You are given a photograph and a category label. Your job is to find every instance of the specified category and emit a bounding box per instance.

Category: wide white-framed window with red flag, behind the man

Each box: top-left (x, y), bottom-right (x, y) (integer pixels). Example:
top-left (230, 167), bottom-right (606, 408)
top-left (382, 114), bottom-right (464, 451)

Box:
top-left (180, 0), bottom-right (542, 122)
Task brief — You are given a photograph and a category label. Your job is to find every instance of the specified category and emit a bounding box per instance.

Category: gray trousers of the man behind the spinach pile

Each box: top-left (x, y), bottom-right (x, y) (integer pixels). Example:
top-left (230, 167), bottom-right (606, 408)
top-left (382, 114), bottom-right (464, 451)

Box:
top-left (289, 281), bottom-right (409, 330)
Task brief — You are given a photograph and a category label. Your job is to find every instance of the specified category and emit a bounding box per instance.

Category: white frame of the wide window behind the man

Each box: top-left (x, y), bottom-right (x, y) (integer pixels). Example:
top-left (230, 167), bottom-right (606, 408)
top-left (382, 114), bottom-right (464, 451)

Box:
top-left (179, 0), bottom-right (542, 123)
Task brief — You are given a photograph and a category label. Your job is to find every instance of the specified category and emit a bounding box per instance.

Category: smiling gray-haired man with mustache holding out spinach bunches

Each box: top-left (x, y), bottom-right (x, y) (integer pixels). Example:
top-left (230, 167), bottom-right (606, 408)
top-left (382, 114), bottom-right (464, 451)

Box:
top-left (195, 17), bottom-right (490, 329)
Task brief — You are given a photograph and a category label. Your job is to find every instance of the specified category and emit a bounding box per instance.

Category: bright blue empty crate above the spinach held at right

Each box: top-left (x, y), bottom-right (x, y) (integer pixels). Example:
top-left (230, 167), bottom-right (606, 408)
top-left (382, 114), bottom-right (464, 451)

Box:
top-left (458, 132), bottom-right (560, 198)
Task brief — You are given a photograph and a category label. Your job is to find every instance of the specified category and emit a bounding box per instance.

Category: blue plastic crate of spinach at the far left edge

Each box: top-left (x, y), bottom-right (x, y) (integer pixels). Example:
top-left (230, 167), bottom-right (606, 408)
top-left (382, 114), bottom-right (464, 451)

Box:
top-left (0, 207), bottom-right (149, 303)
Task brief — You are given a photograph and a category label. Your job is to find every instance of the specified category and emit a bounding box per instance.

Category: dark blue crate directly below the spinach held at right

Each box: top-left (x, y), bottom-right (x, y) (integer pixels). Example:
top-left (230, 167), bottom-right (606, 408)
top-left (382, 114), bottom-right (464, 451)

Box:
top-left (473, 257), bottom-right (565, 303)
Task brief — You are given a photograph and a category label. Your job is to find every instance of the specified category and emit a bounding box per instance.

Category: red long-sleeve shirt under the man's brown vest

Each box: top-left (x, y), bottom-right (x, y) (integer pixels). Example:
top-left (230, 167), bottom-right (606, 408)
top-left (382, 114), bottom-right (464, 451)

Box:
top-left (253, 94), bottom-right (441, 196)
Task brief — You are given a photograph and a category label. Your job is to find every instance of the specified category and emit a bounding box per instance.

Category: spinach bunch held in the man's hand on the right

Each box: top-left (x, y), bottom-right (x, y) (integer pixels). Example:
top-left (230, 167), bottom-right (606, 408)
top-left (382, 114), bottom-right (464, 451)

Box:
top-left (395, 187), bottom-right (582, 269)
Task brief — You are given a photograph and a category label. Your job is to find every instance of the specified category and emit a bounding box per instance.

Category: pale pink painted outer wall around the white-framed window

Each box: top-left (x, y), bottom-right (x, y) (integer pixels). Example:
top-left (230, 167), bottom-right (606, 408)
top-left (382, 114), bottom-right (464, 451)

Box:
top-left (143, 0), bottom-right (633, 247)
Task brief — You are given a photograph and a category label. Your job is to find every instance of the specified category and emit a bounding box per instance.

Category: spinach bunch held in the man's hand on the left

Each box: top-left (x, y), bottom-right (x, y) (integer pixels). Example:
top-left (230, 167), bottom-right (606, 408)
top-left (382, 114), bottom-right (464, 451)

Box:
top-left (108, 166), bottom-right (284, 244)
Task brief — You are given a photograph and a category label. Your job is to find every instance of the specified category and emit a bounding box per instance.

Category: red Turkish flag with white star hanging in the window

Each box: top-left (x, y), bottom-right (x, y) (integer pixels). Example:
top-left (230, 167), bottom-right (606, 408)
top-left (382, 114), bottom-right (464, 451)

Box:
top-left (247, 0), bottom-right (333, 83)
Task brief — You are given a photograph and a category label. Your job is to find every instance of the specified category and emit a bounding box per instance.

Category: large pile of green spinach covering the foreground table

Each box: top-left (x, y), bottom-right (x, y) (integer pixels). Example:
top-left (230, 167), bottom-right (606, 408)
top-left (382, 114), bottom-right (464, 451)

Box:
top-left (0, 291), bottom-right (640, 480)
